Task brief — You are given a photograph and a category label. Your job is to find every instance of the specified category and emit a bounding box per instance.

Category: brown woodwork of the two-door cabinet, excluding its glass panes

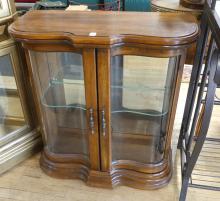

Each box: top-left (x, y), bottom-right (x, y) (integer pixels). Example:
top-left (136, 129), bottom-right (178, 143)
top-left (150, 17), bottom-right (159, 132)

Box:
top-left (9, 11), bottom-right (199, 189)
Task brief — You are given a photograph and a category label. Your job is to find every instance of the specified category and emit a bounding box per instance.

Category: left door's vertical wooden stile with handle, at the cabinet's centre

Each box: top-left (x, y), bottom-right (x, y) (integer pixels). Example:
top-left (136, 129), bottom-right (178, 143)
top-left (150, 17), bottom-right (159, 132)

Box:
top-left (83, 48), bottom-right (100, 171)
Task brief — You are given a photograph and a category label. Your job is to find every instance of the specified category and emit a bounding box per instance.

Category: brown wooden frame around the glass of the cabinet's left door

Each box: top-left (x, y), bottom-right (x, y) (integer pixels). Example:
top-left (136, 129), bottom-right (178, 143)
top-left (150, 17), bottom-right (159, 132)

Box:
top-left (22, 40), bottom-right (100, 171)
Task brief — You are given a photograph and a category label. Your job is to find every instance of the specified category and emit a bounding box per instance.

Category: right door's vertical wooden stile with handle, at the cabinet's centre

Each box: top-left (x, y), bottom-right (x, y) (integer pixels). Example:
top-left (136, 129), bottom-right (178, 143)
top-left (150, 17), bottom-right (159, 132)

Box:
top-left (98, 49), bottom-right (112, 172)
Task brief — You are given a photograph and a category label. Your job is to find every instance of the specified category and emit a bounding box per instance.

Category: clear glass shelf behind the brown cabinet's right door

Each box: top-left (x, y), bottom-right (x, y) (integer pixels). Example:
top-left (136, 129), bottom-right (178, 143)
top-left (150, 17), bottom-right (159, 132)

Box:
top-left (111, 85), bottom-right (171, 114)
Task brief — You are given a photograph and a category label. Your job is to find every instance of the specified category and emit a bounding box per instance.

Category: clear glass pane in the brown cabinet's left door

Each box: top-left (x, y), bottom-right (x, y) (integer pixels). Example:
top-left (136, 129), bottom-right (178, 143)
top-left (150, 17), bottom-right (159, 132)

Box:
top-left (30, 51), bottom-right (88, 154)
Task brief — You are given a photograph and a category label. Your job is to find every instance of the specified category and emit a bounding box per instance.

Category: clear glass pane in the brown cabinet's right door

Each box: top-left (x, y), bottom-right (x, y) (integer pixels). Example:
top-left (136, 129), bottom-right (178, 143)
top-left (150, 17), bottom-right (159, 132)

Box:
top-left (111, 56), bottom-right (175, 163)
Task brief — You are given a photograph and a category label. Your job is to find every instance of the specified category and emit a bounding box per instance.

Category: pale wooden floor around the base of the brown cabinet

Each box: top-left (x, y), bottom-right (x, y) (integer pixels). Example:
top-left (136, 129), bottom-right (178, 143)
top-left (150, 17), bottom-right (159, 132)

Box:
top-left (0, 83), bottom-right (220, 201)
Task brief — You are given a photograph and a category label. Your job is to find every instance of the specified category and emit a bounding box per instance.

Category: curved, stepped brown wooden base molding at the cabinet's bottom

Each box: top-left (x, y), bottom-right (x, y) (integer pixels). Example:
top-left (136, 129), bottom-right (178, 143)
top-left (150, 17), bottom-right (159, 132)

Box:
top-left (40, 150), bottom-right (172, 189)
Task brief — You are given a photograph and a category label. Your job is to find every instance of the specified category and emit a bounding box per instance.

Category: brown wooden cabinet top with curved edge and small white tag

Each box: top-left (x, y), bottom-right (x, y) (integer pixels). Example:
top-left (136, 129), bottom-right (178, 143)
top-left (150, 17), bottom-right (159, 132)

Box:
top-left (9, 10), bottom-right (199, 46)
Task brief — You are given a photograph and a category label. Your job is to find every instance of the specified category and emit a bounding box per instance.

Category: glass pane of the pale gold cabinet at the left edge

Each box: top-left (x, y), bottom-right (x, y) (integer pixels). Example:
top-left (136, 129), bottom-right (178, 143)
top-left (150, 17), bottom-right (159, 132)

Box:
top-left (0, 54), bottom-right (25, 138)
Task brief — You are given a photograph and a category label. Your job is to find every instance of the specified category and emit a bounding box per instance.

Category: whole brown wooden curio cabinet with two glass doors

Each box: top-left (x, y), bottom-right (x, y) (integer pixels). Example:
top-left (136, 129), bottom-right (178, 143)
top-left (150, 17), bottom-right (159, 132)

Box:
top-left (9, 11), bottom-right (198, 189)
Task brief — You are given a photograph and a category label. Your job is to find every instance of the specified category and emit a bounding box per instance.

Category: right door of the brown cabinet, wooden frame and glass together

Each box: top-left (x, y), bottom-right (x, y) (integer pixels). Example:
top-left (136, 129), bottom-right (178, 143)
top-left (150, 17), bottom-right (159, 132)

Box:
top-left (98, 47), bottom-right (180, 173)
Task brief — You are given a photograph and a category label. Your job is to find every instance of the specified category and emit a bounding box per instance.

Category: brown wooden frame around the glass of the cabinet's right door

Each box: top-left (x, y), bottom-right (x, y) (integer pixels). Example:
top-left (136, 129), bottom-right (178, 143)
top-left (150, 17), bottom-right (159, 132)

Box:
top-left (97, 45), bottom-right (186, 173)
